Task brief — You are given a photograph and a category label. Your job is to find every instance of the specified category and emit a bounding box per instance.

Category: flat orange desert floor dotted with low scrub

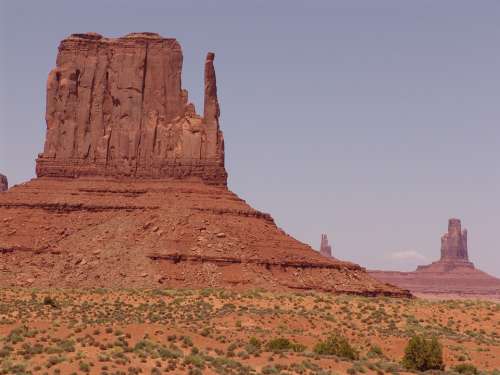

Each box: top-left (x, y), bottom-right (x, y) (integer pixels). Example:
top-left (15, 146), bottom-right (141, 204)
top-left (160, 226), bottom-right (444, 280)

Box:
top-left (0, 289), bottom-right (500, 374)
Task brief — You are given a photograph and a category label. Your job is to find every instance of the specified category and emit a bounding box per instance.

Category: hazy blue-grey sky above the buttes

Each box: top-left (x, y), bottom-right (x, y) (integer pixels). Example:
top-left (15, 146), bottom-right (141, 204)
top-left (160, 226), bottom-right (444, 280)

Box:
top-left (0, 0), bottom-right (500, 276)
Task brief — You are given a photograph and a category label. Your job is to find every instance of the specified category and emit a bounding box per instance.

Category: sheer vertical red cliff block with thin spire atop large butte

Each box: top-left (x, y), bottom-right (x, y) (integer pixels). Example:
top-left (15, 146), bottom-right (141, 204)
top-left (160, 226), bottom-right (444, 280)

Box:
top-left (37, 33), bottom-right (227, 185)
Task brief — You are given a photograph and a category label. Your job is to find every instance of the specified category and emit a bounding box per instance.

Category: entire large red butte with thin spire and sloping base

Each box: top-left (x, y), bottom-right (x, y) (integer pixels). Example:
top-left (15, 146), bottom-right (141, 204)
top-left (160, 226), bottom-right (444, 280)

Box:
top-left (0, 33), bottom-right (410, 297)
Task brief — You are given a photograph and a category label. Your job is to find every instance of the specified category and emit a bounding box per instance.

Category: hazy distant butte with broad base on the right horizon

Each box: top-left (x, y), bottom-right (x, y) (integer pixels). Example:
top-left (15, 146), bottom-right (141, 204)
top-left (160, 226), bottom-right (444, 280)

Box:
top-left (369, 219), bottom-right (500, 299)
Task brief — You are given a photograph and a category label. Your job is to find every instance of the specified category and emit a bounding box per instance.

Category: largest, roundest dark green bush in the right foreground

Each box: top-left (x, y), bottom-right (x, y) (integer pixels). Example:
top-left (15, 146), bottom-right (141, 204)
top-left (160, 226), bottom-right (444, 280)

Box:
top-left (403, 335), bottom-right (444, 371)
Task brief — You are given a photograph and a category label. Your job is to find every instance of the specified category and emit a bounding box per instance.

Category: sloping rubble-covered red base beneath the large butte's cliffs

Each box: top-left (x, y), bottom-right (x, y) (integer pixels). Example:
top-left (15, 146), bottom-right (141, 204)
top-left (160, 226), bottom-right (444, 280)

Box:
top-left (0, 177), bottom-right (409, 296)
